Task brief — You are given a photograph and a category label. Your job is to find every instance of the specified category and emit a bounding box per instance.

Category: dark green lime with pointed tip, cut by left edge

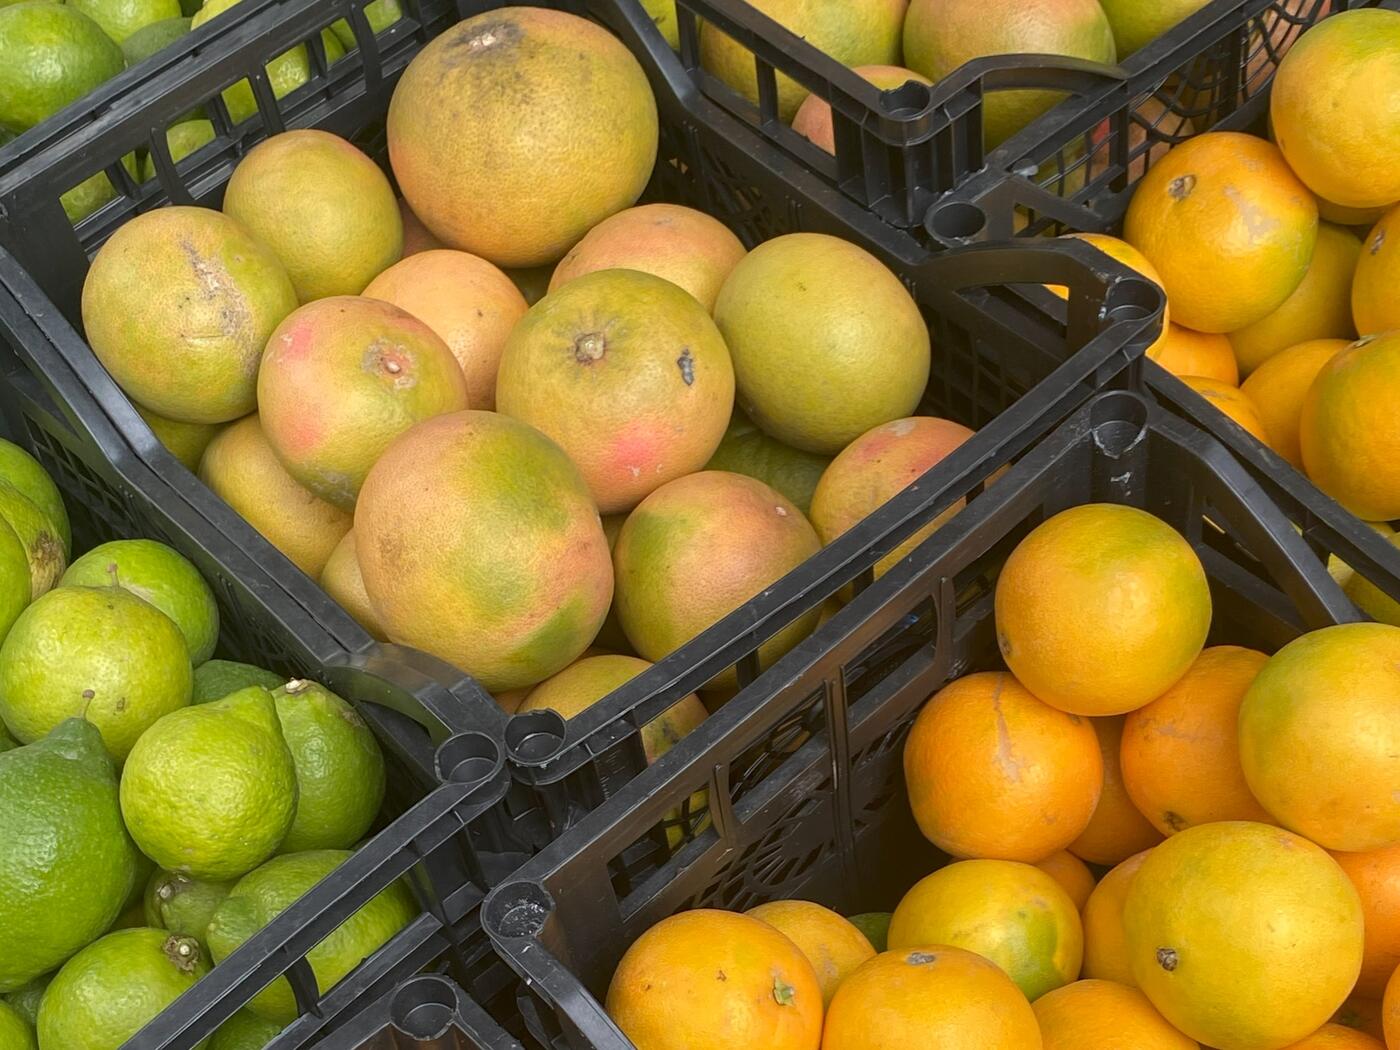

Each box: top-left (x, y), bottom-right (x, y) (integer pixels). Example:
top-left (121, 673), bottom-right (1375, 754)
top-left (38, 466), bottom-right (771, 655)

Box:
top-left (0, 718), bottom-right (136, 996)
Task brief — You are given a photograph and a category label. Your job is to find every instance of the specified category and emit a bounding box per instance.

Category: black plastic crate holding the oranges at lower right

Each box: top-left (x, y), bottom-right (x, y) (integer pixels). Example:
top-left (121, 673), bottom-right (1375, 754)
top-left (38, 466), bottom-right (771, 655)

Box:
top-left (483, 391), bottom-right (1400, 1050)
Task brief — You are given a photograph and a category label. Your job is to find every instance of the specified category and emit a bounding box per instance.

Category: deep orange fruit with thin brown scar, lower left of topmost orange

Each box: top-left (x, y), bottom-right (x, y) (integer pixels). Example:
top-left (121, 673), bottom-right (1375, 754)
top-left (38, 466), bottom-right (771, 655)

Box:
top-left (904, 672), bottom-right (1103, 864)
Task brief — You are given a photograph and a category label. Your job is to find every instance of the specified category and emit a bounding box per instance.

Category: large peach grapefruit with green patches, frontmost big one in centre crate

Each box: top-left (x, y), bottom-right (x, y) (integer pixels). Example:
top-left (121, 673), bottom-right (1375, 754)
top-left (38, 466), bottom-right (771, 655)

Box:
top-left (354, 414), bottom-right (613, 700)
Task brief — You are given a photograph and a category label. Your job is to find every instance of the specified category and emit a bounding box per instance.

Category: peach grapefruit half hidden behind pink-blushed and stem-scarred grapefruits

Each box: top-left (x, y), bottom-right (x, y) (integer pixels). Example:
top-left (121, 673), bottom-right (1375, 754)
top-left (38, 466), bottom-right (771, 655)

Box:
top-left (364, 249), bottom-right (528, 409)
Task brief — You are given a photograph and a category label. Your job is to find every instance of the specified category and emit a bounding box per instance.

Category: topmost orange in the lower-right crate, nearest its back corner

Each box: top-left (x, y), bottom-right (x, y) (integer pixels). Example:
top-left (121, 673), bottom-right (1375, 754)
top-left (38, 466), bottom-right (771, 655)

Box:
top-left (995, 503), bottom-right (1211, 722)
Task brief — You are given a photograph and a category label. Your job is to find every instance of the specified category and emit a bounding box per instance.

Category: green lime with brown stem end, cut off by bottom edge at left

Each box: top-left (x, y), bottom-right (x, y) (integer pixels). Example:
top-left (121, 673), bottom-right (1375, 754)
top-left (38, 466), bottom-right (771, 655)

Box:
top-left (38, 927), bottom-right (209, 1050)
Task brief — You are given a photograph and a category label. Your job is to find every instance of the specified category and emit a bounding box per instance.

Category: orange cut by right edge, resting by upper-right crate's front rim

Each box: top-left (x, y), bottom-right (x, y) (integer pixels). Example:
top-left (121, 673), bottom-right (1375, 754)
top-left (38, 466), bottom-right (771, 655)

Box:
top-left (1298, 330), bottom-right (1400, 521)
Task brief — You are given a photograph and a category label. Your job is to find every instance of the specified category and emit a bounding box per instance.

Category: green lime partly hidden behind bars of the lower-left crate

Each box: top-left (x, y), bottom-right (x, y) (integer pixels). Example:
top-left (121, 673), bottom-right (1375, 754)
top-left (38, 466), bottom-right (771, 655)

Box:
top-left (209, 850), bottom-right (419, 1025)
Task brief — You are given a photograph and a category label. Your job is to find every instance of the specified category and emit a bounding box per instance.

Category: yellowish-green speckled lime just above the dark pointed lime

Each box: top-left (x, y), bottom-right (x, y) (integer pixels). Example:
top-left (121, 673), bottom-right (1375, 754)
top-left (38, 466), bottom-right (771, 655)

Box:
top-left (0, 587), bottom-right (193, 762)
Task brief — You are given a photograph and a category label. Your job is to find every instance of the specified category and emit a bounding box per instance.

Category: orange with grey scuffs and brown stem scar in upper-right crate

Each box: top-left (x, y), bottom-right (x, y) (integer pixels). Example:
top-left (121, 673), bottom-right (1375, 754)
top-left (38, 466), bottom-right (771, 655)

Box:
top-left (1123, 132), bottom-right (1317, 332)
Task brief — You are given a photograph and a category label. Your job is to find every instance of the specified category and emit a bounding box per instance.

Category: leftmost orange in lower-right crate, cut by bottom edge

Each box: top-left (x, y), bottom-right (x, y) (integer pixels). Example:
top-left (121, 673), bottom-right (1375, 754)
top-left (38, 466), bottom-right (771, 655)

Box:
top-left (606, 909), bottom-right (822, 1050)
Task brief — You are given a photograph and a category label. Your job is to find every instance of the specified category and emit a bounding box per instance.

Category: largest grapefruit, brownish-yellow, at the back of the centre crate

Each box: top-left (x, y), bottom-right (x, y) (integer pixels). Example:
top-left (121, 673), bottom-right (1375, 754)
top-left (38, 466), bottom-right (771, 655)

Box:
top-left (388, 7), bottom-right (657, 266)
